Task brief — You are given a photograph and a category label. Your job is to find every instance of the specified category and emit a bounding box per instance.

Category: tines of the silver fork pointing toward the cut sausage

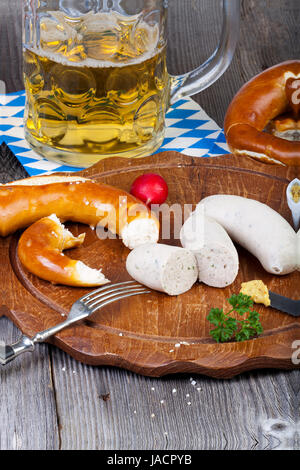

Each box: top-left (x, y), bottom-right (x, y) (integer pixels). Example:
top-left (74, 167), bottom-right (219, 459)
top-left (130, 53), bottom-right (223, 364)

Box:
top-left (80, 281), bottom-right (151, 313)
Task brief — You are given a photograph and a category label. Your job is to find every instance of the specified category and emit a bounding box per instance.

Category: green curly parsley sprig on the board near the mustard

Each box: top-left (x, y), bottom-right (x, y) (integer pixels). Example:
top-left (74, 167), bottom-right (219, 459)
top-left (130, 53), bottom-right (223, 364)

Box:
top-left (207, 294), bottom-right (263, 343)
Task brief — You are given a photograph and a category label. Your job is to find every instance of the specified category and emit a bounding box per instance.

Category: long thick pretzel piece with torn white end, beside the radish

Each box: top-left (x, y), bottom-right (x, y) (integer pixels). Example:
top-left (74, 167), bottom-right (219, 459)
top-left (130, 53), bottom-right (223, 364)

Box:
top-left (0, 176), bottom-right (159, 249)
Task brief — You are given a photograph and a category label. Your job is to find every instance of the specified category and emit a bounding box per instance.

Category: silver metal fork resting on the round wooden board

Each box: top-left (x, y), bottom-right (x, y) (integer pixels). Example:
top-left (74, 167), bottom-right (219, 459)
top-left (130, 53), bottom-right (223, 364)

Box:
top-left (0, 281), bottom-right (151, 365)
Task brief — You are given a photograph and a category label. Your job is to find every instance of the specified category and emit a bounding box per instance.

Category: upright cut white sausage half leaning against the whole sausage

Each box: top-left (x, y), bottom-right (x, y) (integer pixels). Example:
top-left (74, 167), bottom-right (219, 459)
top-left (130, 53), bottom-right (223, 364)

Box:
top-left (180, 210), bottom-right (239, 288)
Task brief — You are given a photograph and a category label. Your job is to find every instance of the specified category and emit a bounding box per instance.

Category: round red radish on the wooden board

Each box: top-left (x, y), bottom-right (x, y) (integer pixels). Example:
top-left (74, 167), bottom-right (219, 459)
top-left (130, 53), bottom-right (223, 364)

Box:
top-left (130, 173), bottom-right (169, 205)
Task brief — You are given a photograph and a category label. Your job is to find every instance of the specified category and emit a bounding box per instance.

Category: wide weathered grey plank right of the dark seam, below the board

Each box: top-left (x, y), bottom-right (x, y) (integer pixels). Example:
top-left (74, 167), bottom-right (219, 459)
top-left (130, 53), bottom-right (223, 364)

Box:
top-left (53, 350), bottom-right (299, 450)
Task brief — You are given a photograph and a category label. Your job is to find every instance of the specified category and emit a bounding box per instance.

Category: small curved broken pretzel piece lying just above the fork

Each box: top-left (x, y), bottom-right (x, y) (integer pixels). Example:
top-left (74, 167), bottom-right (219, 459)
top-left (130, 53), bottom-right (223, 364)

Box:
top-left (18, 214), bottom-right (109, 287)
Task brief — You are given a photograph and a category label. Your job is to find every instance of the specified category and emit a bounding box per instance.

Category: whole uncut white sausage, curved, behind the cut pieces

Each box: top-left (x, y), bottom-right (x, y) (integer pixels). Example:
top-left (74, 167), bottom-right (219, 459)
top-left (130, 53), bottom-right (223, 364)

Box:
top-left (196, 195), bottom-right (297, 275)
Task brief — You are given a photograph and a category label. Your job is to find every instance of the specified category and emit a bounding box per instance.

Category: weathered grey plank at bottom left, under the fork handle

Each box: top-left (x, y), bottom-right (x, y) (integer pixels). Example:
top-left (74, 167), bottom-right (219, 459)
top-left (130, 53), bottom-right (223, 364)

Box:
top-left (0, 317), bottom-right (59, 450)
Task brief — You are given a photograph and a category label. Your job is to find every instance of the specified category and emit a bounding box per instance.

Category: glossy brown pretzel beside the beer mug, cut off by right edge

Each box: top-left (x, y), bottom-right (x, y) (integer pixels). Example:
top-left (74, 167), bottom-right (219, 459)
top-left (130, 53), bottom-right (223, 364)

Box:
top-left (224, 61), bottom-right (300, 166)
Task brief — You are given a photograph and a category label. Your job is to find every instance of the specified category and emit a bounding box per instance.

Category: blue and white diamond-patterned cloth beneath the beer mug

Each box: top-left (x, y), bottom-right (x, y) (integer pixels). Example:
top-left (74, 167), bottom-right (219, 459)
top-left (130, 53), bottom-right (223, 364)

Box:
top-left (0, 91), bottom-right (230, 176)
